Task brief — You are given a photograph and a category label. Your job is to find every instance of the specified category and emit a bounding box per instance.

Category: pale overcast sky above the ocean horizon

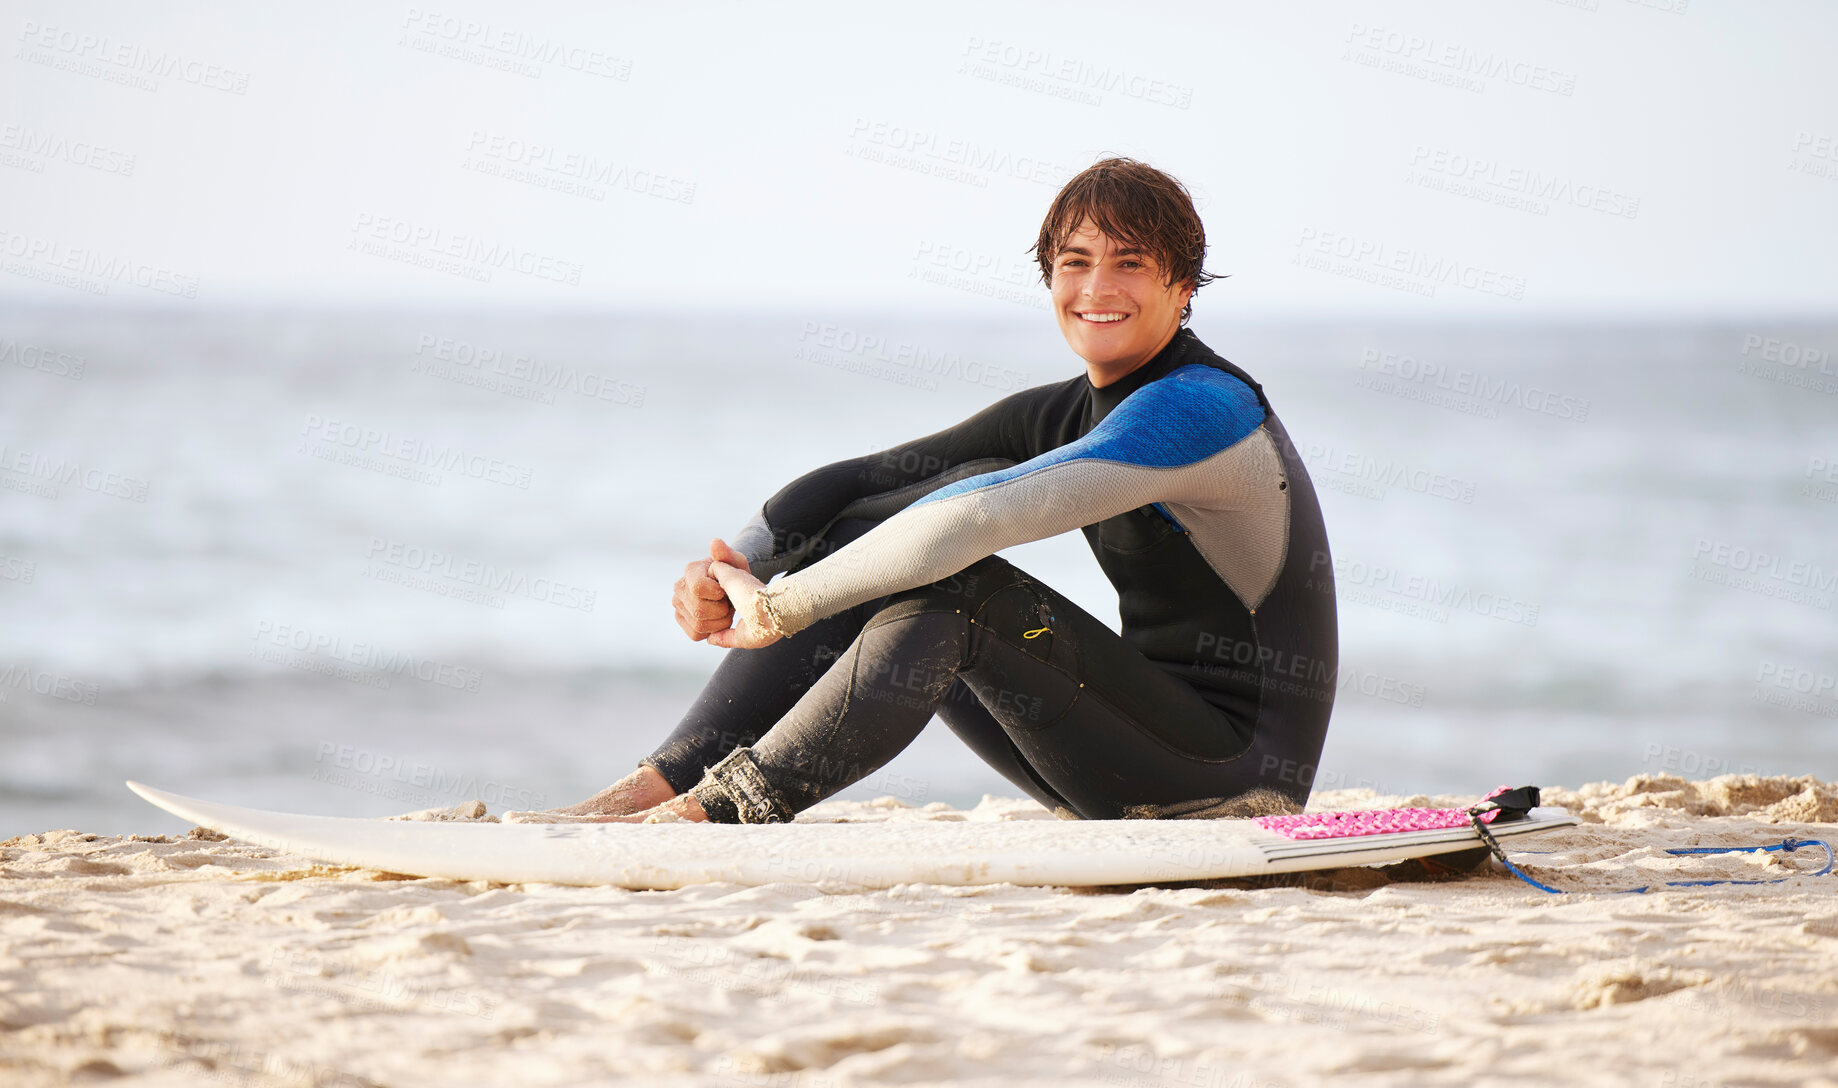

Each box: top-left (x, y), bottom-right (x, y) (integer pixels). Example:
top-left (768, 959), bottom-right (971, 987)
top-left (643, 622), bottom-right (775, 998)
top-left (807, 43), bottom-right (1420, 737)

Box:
top-left (0, 0), bottom-right (1838, 318)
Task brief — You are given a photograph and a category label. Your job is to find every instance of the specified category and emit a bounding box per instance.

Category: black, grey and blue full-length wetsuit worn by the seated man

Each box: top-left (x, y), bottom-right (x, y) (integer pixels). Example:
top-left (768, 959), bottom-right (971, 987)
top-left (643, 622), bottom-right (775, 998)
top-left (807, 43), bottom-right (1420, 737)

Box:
top-left (643, 329), bottom-right (1338, 823)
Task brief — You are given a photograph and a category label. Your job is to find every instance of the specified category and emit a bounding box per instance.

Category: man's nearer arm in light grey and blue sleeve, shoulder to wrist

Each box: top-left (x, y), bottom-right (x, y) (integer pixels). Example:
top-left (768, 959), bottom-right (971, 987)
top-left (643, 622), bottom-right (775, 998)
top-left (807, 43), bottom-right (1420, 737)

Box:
top-left (750, 366), bottom-right (1265, 634)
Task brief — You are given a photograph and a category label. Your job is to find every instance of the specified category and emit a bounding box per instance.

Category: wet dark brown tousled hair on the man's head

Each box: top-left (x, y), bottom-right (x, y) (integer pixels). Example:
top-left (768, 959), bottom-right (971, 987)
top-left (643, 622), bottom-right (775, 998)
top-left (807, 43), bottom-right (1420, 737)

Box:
top-left (1027, 158), bottom-right (1222, 325)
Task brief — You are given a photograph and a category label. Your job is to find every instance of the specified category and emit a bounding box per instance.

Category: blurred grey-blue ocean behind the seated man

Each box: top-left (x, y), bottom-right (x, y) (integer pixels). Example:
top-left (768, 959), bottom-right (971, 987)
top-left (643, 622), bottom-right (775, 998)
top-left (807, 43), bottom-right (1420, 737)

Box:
top-left (0, 307), bottom-right (1838, 836)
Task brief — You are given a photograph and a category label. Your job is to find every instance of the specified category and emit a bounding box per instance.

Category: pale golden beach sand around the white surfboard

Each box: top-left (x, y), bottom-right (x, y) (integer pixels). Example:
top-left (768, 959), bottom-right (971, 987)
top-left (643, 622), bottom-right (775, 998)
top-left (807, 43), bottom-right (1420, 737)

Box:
top-left (0, 776), bottom-right (1838, 1088)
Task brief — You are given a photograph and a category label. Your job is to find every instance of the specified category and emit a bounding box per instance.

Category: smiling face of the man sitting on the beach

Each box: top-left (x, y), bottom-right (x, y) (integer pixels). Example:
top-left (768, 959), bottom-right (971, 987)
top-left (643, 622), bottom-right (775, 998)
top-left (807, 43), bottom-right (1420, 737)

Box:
top-left (1053, 219), bottom-right (1193, 377)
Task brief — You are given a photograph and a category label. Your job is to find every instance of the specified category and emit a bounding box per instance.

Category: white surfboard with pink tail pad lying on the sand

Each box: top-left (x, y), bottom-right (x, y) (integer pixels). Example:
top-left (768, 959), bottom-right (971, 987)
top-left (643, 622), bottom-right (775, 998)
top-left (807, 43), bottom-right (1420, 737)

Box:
top-left (127, 781), bottom-right (1577, 890)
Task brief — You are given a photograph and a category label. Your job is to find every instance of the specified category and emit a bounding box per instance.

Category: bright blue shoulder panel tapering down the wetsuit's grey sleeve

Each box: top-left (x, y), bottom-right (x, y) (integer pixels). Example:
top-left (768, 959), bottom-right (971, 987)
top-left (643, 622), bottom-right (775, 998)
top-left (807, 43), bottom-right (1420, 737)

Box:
top-left (913, 364), bottom-right (1265, 507)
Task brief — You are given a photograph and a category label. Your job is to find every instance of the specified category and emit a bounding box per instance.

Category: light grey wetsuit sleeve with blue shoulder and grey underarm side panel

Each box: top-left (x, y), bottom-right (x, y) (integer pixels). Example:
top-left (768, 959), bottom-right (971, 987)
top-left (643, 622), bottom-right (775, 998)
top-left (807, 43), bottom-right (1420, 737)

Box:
top-left (761, 368), bottom-right (1288, 634)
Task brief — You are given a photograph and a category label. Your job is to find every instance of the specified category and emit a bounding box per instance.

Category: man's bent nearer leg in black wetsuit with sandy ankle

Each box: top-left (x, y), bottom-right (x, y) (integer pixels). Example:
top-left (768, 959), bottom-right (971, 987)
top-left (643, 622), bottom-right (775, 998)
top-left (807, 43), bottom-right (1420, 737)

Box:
top-left (691, 557), bottom-right (1296, 822)
